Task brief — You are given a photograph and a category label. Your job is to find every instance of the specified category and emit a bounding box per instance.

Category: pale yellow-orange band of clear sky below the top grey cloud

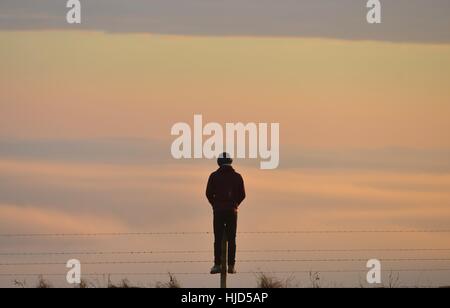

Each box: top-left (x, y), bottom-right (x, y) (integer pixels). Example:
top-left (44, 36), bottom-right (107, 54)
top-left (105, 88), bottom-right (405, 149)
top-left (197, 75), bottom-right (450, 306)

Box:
top-left (0, 32), bottom-right (450, 148)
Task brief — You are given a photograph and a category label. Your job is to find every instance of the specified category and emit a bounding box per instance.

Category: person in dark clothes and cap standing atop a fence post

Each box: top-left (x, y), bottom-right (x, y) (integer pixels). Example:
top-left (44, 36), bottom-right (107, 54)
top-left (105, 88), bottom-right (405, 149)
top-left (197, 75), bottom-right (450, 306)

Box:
top-left (206, 153), bottom-right (245, 274)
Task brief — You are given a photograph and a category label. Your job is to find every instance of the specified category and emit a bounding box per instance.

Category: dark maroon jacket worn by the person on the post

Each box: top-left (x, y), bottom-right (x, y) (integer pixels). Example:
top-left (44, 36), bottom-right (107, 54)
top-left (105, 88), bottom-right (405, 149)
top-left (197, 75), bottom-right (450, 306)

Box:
top-left (206, 165), bottom-right (245, 210)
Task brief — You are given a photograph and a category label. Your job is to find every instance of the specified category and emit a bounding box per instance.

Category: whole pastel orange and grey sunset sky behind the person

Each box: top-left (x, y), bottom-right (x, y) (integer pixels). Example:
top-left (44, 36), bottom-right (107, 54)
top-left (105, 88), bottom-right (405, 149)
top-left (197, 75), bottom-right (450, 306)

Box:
top-left (0, 0), bottom-right (450, 287)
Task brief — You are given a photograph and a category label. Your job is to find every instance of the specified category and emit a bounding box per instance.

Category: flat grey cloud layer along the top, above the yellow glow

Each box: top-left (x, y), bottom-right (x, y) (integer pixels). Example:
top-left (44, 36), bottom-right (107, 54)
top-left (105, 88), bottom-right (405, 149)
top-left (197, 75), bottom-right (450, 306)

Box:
top-left (0, 0), bottom-right (450, 43)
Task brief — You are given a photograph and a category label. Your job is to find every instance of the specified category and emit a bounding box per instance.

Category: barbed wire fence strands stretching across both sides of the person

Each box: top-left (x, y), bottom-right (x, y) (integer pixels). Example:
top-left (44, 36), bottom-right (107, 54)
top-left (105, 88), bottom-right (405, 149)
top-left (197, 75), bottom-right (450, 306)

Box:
top-left (0, 229), bottom-right (450, 286)
